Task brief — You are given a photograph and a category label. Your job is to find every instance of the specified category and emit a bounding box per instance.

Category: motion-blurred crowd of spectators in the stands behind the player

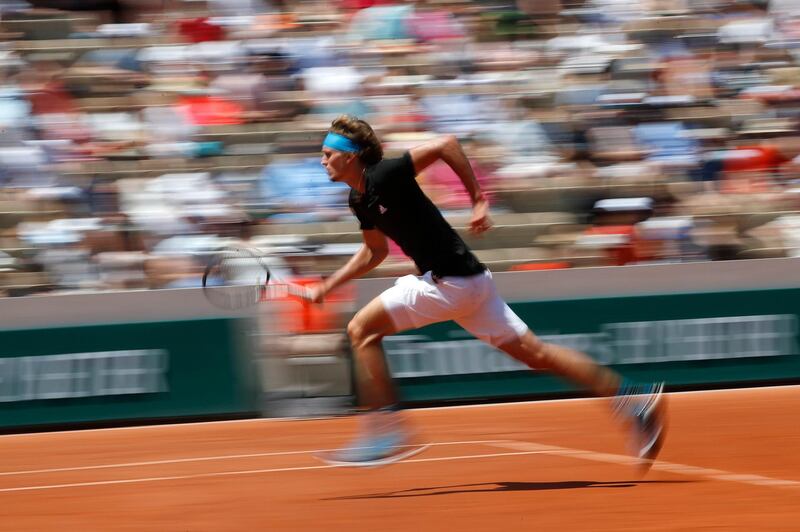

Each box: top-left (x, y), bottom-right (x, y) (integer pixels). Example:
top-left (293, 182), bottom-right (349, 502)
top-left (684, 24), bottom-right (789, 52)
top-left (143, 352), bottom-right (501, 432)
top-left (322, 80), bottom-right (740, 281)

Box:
top-left (0, 0), bottom-right (800, 296)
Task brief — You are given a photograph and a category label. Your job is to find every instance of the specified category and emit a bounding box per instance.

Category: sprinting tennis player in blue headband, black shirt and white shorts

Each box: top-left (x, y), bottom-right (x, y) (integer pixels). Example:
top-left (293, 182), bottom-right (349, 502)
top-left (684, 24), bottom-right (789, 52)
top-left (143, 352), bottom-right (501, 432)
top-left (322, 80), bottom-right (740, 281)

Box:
top-left (308, 116), bottom-right (666, 466)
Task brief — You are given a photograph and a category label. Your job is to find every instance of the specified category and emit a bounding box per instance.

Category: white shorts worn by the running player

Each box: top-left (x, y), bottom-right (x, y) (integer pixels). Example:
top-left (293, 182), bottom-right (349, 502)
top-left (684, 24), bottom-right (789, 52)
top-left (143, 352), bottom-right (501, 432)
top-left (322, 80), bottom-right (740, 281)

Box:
top-left (380, 270), bottom-right (528, 347)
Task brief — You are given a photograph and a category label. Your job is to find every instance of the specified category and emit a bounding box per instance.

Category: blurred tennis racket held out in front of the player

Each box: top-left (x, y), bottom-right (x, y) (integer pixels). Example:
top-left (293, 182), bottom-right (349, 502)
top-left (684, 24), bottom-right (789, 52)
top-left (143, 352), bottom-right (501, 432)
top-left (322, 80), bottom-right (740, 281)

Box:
top-left (203, 246), bottom-right (309, 310)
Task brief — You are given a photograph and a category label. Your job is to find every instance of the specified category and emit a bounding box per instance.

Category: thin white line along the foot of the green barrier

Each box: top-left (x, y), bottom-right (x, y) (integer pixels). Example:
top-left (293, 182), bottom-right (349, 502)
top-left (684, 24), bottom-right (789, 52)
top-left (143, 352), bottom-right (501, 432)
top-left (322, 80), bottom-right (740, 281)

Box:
top-left (0, 384), bottom-right (800, 439)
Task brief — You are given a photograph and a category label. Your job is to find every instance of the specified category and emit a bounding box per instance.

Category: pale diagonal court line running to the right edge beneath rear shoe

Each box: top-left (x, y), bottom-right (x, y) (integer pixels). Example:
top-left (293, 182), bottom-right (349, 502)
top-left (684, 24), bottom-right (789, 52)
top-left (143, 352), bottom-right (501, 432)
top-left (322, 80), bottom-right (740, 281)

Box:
top-left (489, 440), bottom-right (800, 488)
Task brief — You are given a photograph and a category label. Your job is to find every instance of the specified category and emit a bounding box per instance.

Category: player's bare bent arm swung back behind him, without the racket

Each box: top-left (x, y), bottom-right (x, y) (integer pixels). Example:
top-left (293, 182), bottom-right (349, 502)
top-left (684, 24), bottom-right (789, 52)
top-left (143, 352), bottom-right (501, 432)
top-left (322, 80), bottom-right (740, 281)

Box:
top-left (408, 135), bottom-right (492, 234)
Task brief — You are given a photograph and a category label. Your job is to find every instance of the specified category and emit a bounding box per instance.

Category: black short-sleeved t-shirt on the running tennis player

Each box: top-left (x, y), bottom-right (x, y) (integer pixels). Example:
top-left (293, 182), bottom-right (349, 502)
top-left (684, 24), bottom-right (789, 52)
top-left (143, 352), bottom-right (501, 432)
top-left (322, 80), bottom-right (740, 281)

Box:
top-left (349, 152), bottom-right (486, 277)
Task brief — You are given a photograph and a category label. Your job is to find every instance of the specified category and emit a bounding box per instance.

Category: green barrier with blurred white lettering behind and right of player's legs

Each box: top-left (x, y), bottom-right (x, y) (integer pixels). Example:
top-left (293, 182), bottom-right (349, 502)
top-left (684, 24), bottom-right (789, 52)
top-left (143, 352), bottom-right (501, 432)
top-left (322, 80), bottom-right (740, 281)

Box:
top-left (384, 288), bottom-right (800, 403)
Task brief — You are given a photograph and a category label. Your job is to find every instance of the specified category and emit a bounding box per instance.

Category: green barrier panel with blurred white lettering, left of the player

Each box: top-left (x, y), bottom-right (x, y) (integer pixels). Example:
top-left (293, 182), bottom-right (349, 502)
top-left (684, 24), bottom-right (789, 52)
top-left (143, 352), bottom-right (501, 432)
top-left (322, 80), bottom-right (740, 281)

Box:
top-left (0, 318), bottom-right (258, 428)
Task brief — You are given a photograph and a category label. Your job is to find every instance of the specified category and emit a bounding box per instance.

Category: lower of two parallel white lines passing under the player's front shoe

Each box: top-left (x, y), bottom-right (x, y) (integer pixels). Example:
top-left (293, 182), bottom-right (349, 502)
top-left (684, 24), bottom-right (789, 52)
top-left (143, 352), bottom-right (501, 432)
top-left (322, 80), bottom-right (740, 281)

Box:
top-left (0, 451), bottom-right (542, 493)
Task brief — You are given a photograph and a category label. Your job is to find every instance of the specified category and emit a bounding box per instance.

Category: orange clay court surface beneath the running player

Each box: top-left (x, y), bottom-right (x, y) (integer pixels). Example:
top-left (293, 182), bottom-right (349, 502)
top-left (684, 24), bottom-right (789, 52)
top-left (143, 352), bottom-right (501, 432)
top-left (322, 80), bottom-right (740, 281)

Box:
top-left (0, 387), bottom-right (800, 532)
